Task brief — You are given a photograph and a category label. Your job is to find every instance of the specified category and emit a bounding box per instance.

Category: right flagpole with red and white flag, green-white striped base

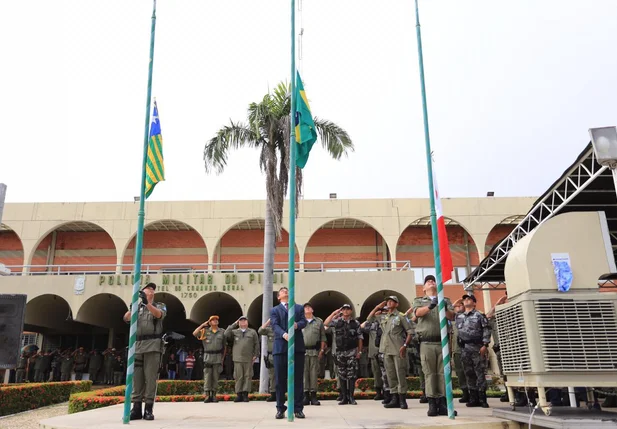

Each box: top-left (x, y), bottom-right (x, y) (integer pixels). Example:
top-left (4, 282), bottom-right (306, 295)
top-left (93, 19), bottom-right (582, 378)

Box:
top-left (415, 0), bottom-right (454, 419)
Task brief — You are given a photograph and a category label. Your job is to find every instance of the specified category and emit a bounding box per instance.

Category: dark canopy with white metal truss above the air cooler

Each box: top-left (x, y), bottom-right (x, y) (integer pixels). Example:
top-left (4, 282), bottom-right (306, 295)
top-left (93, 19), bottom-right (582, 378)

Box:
top-left (463, 143), bottom-right (617, 289)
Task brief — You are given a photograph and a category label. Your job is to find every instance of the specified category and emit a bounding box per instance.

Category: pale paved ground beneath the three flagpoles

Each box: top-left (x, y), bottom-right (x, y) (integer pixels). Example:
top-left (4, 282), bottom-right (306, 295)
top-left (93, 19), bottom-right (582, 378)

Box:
top-left (40, 400), bottom-right (518, 429)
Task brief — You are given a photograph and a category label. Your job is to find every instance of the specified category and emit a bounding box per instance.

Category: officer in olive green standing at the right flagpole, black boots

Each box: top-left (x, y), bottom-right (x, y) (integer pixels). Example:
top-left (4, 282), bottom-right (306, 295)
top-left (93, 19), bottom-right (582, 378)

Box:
top-left (413, 275), bottom-right (454, 417)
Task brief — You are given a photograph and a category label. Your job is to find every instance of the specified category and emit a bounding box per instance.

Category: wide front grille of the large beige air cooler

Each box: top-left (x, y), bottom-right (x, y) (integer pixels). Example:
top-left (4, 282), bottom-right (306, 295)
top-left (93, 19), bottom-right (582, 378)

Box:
top-left (535, 300), bottom-right (617, 371)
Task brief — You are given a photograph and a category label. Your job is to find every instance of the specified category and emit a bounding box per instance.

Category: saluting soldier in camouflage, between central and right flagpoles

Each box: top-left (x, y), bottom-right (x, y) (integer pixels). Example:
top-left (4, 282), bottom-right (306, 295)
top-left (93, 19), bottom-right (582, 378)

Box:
top-left (324, 304), bottom-right (363, 405)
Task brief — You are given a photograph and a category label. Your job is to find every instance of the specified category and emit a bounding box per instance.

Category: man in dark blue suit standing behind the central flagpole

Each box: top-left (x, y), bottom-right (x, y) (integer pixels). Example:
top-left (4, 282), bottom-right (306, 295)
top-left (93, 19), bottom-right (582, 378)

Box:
top-left (270, 287), bottom-right (306, 419)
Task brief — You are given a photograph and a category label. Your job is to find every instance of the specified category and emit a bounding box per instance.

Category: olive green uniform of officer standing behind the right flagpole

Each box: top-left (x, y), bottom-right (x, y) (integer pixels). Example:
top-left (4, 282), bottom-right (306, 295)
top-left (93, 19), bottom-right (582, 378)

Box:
top-left (413, 296), bottom-right (453, 398)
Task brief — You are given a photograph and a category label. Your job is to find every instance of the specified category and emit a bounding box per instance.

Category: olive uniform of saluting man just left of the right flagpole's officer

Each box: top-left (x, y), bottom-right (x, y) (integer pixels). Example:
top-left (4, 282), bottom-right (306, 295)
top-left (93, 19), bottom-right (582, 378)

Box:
top-left (369, 309), bottom-right (413, 395)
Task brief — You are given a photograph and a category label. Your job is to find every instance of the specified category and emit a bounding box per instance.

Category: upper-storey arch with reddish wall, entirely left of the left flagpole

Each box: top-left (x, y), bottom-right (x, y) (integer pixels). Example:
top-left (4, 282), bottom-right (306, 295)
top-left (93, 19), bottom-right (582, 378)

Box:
top-left (28, 221), bottom-right (117, 273)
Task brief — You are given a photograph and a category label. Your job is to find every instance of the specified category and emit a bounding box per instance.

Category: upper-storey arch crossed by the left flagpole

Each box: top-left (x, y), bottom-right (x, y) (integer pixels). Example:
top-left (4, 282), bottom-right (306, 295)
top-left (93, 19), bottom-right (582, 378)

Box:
top-left (122, 219), bottom-right (208, 272)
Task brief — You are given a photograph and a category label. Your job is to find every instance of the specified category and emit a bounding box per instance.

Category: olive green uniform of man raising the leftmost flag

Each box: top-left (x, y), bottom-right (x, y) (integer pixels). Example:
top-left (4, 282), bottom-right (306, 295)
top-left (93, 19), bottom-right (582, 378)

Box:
top-left (131, 302), bottom-right (167, 404)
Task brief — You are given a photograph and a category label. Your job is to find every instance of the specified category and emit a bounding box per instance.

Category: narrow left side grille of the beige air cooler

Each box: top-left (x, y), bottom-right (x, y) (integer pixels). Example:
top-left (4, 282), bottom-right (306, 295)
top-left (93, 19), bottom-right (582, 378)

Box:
top-left (495, 304), bottom-right (531, 374)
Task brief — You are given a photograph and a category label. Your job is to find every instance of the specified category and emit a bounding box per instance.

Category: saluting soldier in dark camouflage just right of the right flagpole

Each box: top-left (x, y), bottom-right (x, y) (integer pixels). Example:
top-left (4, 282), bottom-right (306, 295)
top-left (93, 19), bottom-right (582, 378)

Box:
top-left (455, 295), bottom-right (491, 408)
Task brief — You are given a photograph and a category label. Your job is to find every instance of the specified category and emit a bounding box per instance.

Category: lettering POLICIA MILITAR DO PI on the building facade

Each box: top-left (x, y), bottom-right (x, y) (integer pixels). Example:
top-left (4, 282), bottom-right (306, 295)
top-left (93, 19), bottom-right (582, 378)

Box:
top-left (98, 273), bottom-right (287, 298)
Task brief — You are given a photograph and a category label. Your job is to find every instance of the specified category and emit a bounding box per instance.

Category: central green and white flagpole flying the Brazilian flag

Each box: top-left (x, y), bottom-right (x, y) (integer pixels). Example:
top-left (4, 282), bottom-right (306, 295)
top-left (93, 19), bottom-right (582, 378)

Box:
top-left (287, 0), bottom-right (296, 422)
